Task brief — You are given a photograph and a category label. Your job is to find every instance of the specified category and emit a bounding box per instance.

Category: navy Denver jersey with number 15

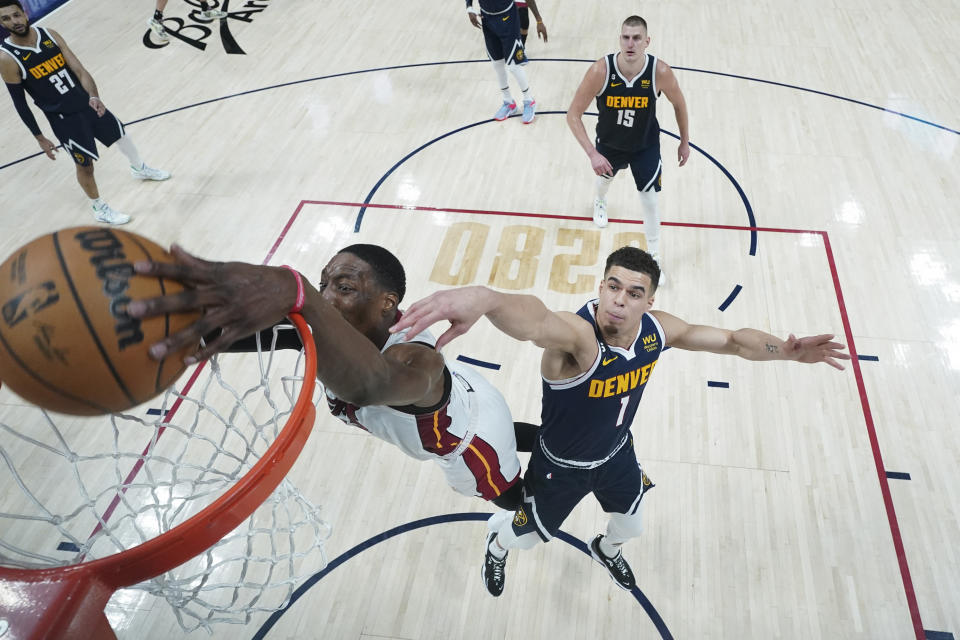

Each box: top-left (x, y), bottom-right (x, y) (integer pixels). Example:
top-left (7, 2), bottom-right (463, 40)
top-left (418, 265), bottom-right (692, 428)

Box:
top-left (597, 53), bottom-right (660, 151)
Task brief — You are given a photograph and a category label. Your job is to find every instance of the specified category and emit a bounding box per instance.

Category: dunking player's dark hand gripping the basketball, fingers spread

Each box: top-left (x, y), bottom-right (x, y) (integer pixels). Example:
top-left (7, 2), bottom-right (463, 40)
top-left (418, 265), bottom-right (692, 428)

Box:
top-left (127, 245), bottom-right (297, 364)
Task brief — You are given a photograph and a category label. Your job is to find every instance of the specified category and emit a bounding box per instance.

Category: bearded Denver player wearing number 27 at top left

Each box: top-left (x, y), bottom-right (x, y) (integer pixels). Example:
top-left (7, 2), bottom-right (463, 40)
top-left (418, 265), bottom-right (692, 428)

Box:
top-left (0, 0), bottom-right (170, 224)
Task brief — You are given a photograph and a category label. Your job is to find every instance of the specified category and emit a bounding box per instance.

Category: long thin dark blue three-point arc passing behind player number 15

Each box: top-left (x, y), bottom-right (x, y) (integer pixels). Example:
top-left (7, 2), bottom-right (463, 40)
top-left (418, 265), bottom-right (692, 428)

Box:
top-left (0, 58), bottom-right (960, 170)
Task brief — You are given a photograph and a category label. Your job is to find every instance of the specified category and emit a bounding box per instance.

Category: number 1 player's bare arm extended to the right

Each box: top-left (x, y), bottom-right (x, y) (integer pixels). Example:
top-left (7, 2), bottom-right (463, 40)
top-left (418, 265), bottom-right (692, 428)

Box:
top-left (651, 311), bottom-right (850, 371)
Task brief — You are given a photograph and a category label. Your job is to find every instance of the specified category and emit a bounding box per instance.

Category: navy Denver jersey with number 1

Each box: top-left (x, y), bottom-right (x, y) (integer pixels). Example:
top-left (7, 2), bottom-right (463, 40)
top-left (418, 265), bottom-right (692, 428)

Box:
top-left (540, 300), bottom-right (664, 468)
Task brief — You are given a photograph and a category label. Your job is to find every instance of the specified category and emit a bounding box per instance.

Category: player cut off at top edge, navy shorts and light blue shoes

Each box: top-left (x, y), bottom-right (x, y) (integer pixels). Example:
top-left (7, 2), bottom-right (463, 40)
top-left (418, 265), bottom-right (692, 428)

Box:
top-left (467, 0), bottom-right (547, 124)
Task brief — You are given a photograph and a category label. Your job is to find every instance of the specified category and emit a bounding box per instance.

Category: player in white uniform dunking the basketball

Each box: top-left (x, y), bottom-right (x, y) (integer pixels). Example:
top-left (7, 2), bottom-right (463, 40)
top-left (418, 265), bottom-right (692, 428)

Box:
top-left (128, 244), bottom-right (530, 509)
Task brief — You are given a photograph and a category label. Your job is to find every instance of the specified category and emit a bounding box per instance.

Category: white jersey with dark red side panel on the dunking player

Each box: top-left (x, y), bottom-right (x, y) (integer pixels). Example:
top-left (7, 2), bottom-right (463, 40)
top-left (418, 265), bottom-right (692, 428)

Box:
top-left (326, 331), bottom-right (488, 460)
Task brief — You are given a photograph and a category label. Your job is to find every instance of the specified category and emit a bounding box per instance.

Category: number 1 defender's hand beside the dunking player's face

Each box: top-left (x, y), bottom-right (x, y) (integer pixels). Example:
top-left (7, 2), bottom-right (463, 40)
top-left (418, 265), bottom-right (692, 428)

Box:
top-left (390, 287), bottom-right (489, 349)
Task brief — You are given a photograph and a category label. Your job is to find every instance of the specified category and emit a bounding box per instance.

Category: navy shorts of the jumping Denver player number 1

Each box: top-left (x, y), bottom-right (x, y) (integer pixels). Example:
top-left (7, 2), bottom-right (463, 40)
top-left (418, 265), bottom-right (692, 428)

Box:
top-left (513, 437), bottom-right (654, 541)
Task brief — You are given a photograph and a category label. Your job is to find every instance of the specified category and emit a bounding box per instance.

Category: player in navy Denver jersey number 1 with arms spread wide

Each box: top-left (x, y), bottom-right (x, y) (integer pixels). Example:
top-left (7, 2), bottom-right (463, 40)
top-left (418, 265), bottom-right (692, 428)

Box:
top-left (391, 247), bottom-right (850, 596)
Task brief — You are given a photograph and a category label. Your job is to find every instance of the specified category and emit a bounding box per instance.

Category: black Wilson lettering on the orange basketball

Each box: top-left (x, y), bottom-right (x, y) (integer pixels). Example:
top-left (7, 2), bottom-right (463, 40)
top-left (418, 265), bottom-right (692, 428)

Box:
top-left (74, 229), bottom-right (143, 351)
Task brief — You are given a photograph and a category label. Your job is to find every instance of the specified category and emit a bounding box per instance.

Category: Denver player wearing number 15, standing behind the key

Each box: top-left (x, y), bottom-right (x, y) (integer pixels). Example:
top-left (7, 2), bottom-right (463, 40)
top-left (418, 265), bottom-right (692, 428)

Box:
top-left (567, 16), bottom-right (690, 284)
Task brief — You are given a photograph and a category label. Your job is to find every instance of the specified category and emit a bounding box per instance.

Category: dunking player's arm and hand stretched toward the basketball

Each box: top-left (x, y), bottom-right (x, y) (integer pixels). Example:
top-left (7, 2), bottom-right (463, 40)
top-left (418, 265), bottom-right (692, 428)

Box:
top-left (127, 246), bottom-right (444, 406)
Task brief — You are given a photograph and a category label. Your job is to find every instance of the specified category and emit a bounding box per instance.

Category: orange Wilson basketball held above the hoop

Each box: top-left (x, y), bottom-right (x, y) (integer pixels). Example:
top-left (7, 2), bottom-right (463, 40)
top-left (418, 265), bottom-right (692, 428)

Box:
top-left (0, 226), bottom-right (198, 415)
